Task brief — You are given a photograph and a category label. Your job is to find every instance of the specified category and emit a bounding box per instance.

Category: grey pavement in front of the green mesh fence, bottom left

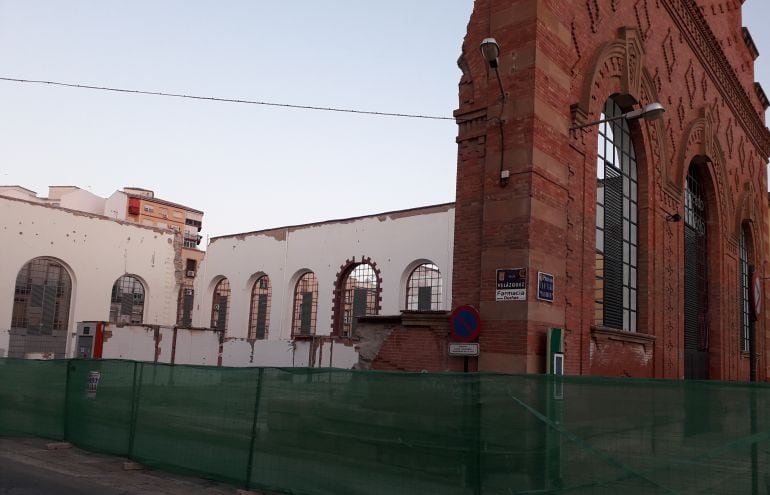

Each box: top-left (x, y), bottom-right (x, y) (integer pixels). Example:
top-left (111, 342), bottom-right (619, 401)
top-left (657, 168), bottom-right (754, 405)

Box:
top-left (0, 438), bottom-right (252, 495)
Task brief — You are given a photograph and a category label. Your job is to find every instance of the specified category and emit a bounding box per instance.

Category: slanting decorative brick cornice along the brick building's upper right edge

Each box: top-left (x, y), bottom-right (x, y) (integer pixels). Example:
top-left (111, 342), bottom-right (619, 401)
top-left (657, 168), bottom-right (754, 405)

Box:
top-left (661, 0), bottom-right (770, 159)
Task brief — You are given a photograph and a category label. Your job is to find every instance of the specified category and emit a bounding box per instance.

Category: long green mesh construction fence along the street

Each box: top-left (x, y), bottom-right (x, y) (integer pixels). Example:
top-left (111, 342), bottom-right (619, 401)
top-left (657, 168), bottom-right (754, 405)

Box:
top-left (0, 359), bottom-right (770, 495)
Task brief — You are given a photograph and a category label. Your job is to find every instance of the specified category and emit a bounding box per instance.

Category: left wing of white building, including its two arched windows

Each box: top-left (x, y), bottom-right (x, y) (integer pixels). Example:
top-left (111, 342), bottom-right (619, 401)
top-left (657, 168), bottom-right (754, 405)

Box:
top-left (0, 196), bottom-right (181, 357)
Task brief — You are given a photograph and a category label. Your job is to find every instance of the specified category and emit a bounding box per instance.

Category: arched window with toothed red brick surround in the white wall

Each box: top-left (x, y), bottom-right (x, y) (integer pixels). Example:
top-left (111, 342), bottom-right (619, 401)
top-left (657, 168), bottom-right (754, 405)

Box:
top-left (335, 263), bottom-right (379, 337)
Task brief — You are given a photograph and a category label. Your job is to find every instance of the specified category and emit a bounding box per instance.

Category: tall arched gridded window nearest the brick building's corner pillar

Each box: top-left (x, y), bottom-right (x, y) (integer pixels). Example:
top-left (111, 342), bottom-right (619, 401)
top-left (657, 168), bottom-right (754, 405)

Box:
top-left (594, 98), bottom-right (639, 332)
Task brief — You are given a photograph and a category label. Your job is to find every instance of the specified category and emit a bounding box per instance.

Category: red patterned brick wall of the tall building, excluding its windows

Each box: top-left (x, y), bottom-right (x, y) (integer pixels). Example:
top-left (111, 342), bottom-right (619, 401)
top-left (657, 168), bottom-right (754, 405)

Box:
top-left (444, 0), bottom-right (770, 380)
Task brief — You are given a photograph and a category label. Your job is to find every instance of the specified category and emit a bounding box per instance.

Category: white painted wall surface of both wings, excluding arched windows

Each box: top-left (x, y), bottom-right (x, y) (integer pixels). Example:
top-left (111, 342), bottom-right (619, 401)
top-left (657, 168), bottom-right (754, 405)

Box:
top-left (0, 196), bottom-right (454, 368)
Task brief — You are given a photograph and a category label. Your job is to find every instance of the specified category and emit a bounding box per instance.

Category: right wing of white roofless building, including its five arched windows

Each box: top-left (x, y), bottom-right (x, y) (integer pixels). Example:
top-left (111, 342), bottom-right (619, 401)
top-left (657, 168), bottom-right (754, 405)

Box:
top-left (193, 204), bottom-right (454, 366)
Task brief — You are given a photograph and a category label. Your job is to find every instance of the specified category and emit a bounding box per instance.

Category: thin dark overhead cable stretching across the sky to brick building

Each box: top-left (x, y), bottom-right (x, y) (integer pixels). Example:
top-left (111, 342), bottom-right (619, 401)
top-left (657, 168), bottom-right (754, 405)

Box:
top-left (0, 76), bottom-right (455, 120)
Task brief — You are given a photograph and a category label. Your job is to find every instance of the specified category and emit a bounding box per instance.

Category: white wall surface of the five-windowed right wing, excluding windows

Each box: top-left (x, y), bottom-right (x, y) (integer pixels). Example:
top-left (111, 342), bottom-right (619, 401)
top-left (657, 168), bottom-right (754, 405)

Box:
top-left (193, 204), bottom-right (454, 366)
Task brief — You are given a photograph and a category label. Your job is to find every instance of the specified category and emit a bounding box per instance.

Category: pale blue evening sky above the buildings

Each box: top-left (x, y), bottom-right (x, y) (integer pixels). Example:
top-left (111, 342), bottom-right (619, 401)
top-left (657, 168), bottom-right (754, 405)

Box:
top-left (0, 0), bottom-right (770, 240)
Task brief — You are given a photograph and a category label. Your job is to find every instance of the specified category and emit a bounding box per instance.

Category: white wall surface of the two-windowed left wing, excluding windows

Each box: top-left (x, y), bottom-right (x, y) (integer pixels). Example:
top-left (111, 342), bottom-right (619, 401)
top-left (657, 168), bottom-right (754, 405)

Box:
top-left (0, 193), bottom-right (178, 357)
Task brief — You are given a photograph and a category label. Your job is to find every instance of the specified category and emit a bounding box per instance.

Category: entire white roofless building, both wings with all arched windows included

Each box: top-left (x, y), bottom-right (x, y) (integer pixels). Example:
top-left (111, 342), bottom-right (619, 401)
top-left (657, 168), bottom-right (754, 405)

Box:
top-left (0, 194), bottom-right (454, 368)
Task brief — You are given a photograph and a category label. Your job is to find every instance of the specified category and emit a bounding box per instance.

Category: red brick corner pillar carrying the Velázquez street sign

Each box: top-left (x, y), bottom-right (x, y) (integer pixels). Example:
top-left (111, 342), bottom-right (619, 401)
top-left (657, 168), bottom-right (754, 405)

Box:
top-left (452, 0), bottom-right (572, 373)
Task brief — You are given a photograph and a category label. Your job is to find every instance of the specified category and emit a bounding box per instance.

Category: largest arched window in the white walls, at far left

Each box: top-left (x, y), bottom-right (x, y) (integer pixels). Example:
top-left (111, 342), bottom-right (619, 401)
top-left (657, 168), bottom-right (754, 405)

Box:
top-left (8, 258), bottom-right (72, 358)
